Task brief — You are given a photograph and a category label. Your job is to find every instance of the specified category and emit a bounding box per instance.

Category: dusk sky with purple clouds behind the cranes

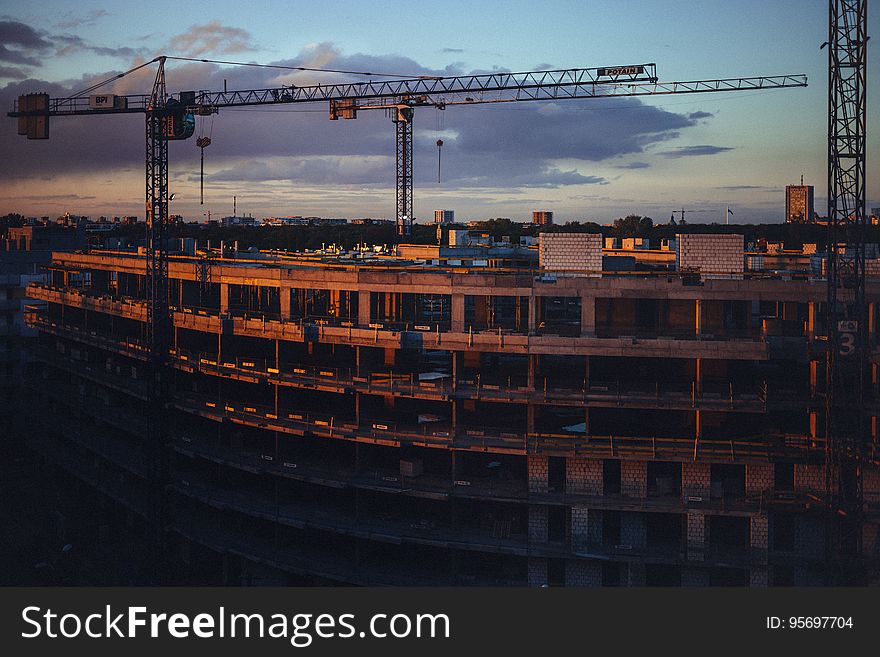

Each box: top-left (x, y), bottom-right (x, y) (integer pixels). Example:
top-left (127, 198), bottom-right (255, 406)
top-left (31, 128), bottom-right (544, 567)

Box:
top-left (0, 0), bottom-right (880, 223)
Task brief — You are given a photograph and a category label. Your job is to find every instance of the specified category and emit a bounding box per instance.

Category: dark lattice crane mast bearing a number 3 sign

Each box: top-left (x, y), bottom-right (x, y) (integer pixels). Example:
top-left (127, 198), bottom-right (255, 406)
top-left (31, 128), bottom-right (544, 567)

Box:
top-left (825, 0), bottom-right (871, 583)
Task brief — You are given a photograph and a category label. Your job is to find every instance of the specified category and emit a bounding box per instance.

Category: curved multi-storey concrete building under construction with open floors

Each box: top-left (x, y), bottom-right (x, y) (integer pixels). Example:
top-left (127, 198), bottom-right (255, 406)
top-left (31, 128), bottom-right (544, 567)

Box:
top-left (18, 233), bottom-right (880, 586)
